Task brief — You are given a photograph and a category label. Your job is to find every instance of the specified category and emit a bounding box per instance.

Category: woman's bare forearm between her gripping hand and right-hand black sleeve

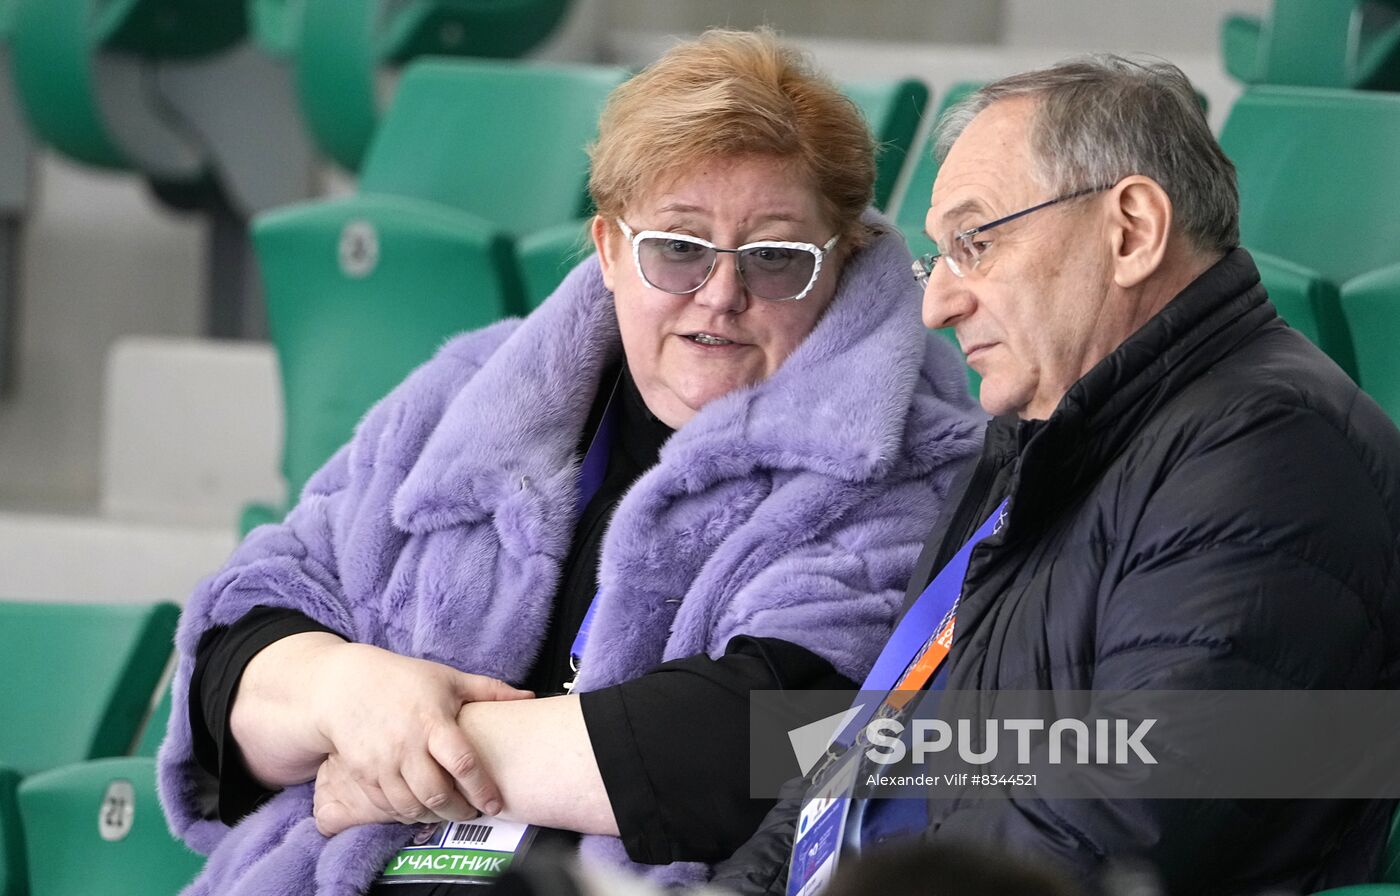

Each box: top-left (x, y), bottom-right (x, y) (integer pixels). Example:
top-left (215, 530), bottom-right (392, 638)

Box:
top-left (458, 696), bottom-right (617, 836)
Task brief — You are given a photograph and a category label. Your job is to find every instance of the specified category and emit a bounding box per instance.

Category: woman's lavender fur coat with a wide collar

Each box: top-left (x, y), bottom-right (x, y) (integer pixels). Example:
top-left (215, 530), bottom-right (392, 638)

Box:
top-left (160, 215), bottom-right (981, 896)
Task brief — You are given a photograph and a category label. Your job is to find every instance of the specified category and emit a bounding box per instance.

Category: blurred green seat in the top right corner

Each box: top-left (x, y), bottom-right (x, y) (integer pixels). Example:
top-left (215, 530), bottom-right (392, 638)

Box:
top-left (1221, 0), bottom-right (1400, 90)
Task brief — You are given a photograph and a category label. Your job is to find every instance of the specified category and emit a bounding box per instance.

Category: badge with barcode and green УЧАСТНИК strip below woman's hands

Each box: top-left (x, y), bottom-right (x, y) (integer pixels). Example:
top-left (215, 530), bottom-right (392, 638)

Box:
top-left (378, 818), bottom-right (535, 883)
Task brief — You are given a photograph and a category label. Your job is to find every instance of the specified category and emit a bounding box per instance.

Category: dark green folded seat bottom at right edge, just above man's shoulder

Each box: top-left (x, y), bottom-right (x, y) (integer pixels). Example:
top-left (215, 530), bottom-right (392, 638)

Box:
top-left (1341, 265), bottom-right (1400, 422)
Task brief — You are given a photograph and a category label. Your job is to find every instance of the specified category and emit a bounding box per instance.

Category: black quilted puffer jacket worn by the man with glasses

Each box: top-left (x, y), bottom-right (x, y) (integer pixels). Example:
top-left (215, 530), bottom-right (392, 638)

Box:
top-left (718, 249), bottom-right (1400, 896)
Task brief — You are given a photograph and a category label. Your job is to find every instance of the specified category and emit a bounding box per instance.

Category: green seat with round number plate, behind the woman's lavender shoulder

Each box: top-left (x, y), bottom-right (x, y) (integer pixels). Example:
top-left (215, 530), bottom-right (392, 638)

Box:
top-left (242, 59), bottom-right (626, 506)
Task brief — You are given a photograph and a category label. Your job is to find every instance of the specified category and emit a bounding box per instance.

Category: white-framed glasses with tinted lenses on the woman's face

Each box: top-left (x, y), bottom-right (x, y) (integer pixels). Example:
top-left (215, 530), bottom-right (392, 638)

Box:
top-left (617, 218), bottom-right (839, 302)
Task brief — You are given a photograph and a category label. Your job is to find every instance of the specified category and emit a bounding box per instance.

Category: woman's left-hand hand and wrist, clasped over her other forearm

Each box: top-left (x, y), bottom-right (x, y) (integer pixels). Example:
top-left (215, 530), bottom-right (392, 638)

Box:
top-left (230, 631), bottom-right (532, 822)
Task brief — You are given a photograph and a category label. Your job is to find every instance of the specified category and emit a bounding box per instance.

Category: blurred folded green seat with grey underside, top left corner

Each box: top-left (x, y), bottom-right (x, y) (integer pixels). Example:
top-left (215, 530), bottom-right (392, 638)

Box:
top-left (8, 0), bottom-right (315, 337)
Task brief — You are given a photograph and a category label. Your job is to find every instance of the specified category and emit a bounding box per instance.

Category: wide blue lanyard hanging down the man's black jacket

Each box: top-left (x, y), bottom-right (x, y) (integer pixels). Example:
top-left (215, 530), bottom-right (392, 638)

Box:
top-left (836, 498), bottom-right (1009, 750)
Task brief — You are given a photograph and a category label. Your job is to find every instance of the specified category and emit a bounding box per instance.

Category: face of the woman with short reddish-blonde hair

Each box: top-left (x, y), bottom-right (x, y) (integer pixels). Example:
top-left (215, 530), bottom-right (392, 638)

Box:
top-left (592, 157), bottom-right (844, 428)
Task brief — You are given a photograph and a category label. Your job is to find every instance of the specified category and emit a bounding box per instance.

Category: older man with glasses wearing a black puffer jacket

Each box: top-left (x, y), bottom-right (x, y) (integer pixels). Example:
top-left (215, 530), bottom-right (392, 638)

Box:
top-left (718, 57), bottom-right (1400, 895)
